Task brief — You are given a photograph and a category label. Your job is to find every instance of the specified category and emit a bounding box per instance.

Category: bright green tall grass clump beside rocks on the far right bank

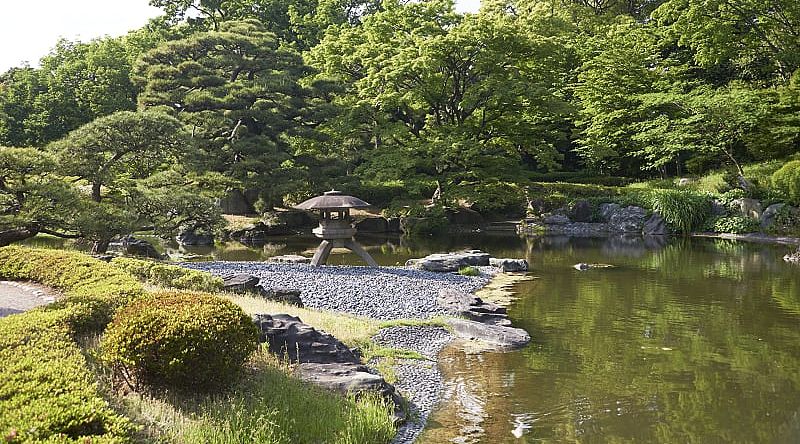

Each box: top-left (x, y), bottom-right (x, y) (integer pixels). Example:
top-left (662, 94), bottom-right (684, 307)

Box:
top-left (646, 190), bottom-right (711, 233)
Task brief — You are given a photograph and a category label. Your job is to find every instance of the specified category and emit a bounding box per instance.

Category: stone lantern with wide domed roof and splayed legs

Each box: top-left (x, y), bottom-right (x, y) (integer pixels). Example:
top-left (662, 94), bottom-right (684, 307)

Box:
top-left (295, 190), bottom-right (378, 267)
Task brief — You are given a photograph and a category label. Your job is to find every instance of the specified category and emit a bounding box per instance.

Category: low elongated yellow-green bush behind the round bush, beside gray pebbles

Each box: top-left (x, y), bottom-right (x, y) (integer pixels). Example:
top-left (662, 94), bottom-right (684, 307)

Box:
top-left (111, 257), bottom-right (223, 292)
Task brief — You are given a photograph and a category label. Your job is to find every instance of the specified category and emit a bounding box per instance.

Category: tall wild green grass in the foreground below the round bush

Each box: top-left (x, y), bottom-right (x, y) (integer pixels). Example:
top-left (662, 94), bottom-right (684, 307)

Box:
top-left (101, 349), bottom-right (395, 444)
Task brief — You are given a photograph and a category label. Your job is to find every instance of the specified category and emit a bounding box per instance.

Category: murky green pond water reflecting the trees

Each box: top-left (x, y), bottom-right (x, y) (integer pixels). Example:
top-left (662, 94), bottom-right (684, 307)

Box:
top-left (25, 234), bottom-right (800, 444)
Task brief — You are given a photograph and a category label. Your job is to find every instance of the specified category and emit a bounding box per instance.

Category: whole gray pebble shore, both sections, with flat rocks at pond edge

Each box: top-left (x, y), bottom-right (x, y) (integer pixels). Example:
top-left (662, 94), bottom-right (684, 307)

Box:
top-left (183, 255), bottom-right (530, 444)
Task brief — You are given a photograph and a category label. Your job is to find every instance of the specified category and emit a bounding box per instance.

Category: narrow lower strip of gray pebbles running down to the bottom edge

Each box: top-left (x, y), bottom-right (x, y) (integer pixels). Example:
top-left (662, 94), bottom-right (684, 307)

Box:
top-left (372, 326), bottom-right (453, 444)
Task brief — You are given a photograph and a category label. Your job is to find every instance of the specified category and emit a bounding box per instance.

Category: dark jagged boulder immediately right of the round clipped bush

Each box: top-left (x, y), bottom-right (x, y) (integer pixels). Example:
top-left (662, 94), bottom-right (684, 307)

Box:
top-left (253, 314), bottom-right (360, 364)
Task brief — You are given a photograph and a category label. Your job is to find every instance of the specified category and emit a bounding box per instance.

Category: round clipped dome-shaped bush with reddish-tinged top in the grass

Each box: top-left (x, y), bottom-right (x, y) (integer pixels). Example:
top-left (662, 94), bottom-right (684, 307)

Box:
top-left (102, 292), bottom-right (258, 391)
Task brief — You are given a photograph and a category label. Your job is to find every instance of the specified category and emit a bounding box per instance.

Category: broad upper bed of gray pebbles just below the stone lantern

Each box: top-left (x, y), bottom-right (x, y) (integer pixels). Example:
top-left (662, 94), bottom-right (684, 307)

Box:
top-left (183, 262), bottom-right (496, 320)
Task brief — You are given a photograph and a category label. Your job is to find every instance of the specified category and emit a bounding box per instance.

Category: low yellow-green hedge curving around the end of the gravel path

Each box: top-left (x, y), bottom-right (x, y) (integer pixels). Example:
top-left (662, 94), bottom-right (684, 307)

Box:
top-left (0, 246), bottom-right (144, 334)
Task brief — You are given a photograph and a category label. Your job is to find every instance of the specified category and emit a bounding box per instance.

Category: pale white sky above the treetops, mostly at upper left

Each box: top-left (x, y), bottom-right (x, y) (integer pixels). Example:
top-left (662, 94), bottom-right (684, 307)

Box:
top-left (0, 0), bottom-right (480, 73)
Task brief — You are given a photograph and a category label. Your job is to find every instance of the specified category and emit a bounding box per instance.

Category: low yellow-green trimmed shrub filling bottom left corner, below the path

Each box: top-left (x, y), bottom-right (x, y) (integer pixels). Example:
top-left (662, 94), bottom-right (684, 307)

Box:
top-left (0, 310), bottom-right (134, 443)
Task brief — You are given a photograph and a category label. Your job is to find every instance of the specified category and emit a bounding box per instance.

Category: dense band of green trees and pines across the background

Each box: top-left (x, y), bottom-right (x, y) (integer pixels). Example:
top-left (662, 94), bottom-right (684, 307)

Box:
top-left (0, 0), bottom-right (800, 239)
